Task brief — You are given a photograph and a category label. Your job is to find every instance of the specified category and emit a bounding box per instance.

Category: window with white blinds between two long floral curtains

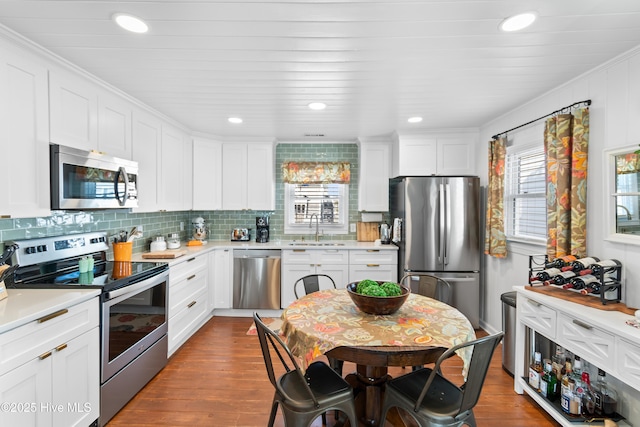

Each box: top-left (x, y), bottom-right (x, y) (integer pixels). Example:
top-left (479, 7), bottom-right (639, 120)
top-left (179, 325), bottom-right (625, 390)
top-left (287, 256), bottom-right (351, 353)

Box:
top-left (504, 144), bottom-right (547, 243)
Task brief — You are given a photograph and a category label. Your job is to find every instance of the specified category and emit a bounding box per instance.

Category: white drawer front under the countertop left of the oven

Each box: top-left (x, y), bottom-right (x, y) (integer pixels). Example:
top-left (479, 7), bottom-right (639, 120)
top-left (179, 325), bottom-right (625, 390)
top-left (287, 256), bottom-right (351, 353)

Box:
top-left (0, 298), bottom-right (100, 375)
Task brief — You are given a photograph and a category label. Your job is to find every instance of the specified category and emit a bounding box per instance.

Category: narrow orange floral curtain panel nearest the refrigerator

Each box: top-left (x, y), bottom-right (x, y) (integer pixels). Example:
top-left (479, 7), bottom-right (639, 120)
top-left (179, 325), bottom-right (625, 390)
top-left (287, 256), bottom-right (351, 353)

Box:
top-left (484, 137), bottom-right (507, 258)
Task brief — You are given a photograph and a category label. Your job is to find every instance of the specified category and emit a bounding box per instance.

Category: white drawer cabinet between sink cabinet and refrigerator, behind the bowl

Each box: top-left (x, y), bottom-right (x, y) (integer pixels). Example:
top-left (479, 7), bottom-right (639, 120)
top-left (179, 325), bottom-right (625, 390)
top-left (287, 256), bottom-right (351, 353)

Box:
top-left (349, 249), bottom-right (398, 283)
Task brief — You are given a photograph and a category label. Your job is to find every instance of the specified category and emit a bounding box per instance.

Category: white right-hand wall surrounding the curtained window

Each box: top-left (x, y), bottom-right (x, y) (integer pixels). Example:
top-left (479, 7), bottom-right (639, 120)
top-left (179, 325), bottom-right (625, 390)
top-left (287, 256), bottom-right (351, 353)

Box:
top-left (477, 46), bottom-right (640, 331)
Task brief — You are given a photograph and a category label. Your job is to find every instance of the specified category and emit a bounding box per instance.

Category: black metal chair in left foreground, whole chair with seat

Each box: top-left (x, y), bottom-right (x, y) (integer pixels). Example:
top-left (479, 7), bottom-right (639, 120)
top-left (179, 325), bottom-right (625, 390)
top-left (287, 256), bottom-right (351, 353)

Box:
top-left (253, 313), bottom-right (358, 427)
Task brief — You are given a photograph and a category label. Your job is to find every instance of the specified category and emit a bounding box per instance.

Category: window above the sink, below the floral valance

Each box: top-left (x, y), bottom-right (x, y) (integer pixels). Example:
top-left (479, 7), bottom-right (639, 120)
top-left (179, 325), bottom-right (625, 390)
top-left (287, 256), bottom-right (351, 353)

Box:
top-left (284, 184), bottom-right (349, 234)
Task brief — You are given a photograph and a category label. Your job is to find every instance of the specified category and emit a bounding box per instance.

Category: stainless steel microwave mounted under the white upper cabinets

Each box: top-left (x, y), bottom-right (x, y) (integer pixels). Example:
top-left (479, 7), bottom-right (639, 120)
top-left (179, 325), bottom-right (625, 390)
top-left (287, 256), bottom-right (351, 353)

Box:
top-left (49, 144), bottom-right (138, 210)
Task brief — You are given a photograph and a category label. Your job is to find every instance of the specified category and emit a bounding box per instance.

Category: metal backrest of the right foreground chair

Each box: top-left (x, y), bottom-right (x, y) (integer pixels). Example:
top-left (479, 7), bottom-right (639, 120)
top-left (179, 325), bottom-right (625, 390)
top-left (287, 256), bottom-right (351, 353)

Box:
top-left (414, 332), bottom-right (504, 413)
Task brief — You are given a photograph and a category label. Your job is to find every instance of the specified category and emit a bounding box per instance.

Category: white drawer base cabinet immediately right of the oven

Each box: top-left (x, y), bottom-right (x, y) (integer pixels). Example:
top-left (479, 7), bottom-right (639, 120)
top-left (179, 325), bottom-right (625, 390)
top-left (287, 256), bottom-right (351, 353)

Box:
top-left (168, 254), bottom-right (210, 356)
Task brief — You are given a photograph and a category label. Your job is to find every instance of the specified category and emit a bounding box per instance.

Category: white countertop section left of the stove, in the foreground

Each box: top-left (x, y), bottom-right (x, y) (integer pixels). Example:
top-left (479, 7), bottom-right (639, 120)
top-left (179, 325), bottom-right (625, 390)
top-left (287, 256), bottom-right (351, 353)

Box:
top-left (0, 289), bottom-right (100, 334)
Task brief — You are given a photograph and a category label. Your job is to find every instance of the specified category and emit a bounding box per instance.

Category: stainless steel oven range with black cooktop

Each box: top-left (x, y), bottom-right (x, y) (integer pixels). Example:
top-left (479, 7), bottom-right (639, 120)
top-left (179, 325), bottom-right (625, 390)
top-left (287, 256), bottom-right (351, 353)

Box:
top-left (11, 232), bottom-right (169, 426)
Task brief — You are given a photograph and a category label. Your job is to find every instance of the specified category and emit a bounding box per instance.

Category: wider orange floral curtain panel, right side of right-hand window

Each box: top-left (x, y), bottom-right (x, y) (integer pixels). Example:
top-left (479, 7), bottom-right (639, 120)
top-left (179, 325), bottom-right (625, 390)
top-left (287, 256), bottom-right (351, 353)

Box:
top-left (544, 108), bottom-right (589, 258)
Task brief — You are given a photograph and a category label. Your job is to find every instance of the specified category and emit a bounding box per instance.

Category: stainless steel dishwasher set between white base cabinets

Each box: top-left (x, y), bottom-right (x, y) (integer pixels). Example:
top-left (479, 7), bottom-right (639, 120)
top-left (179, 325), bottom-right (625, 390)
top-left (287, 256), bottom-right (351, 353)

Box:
top-left (233, 249), bottom-right (280, 309)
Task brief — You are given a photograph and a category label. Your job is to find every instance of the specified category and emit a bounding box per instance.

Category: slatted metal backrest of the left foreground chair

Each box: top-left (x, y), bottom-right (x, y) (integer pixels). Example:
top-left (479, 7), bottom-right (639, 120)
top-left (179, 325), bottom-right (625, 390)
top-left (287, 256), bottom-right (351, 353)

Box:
top-left (253, 313), bottom-right (318, 405)
